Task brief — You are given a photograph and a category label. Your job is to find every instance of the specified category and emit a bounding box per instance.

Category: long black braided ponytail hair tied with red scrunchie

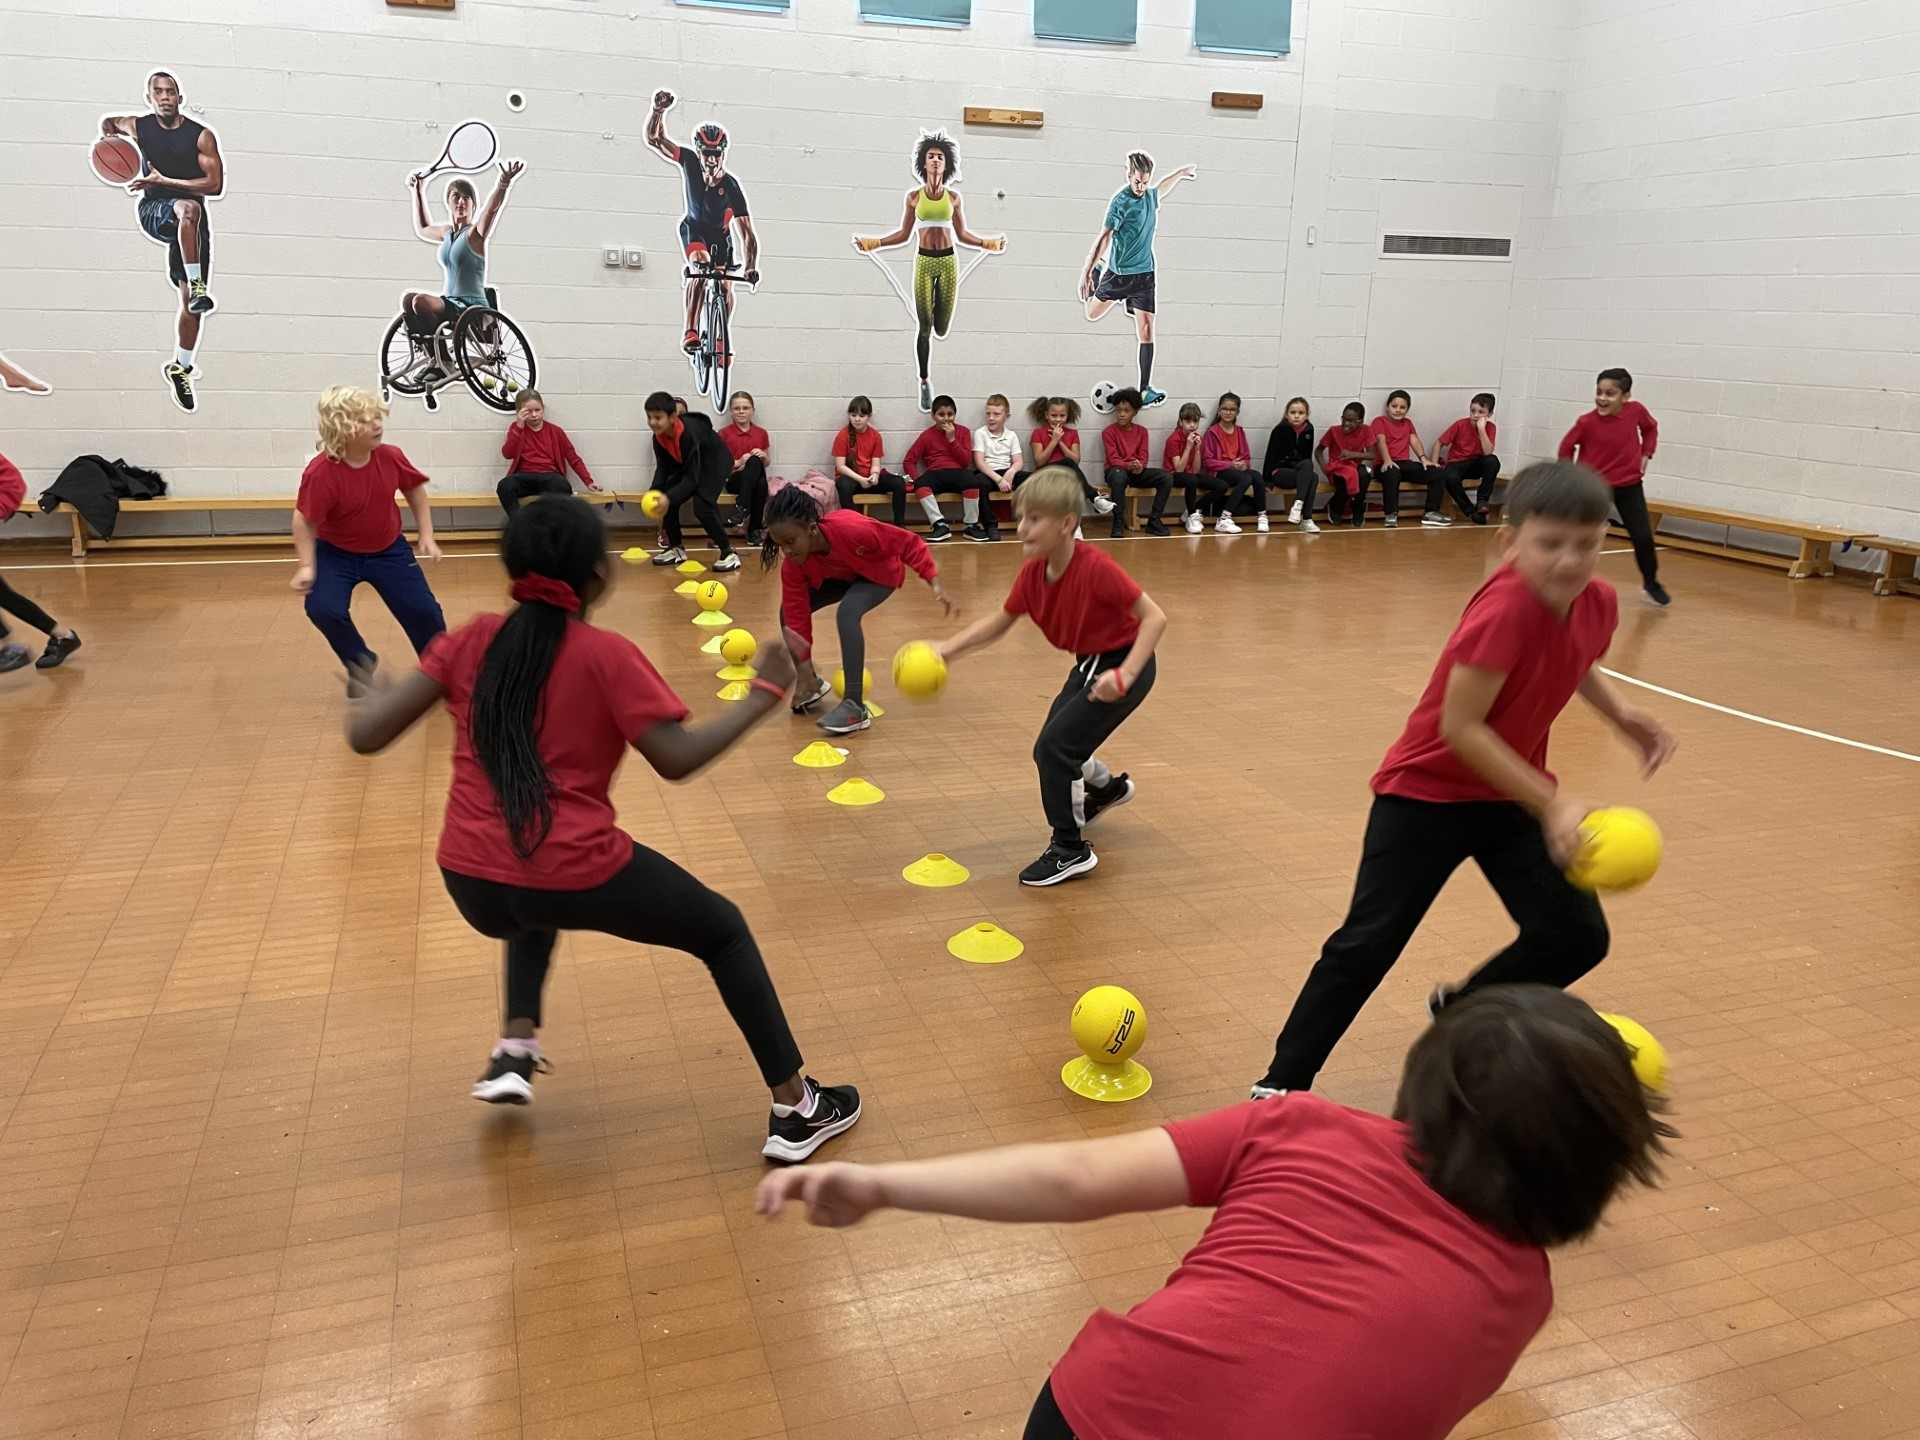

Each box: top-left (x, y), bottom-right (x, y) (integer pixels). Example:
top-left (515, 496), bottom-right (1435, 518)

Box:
top-left (467, 495), bottom-right (607, 860)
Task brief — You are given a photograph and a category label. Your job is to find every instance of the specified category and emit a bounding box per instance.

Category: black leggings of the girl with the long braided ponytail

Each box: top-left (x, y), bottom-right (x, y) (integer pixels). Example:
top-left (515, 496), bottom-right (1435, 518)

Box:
top-left (440, 843), bottom-right (801, 1089)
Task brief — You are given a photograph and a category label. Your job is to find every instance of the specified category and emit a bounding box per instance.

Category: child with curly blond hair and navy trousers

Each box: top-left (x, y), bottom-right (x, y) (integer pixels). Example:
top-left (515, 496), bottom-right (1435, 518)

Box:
top-left (292, 386), bottom-right (447, 697)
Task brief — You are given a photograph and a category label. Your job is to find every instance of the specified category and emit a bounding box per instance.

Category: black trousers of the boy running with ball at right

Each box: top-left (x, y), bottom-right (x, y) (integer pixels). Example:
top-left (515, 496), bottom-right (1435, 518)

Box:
top-left (1261, 795), bottom-right (1609, 1091)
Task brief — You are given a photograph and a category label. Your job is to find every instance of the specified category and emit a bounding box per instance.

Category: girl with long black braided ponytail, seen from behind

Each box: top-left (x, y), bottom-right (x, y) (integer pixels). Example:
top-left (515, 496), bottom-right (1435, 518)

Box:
top-left (348, 495), bottom-right (860, 1162)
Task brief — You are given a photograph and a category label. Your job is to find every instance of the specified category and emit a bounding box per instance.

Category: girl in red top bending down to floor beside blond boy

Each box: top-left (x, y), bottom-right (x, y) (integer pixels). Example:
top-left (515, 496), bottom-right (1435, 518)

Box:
top-left (760, 486), bottom-right (960, 735)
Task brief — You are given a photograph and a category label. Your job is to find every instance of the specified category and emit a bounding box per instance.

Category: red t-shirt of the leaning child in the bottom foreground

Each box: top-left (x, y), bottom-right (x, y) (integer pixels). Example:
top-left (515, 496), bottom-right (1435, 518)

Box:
top-left (1052, 1092), bottom-right (1553, 1440)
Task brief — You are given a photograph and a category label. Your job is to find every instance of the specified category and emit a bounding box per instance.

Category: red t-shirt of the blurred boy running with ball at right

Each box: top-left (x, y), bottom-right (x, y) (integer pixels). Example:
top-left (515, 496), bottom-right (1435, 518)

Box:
top-left (1373, 564), bottom-right (1620, 801)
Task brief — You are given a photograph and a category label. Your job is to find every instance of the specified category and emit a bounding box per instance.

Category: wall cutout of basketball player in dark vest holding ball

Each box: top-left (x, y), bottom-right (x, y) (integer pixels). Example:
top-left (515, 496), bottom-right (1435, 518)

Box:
top-left (94, 69), bottom-right (227, 411)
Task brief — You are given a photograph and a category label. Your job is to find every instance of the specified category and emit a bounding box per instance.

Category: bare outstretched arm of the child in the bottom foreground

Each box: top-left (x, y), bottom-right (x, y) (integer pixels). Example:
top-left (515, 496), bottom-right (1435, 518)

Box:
top-left (753, 1127), bottom-right (1190, 1227)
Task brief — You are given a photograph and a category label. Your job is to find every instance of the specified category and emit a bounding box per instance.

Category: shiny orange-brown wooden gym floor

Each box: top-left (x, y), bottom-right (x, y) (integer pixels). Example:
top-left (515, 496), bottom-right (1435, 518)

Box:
top-left (0, 528), bottom-right (1920, 1440)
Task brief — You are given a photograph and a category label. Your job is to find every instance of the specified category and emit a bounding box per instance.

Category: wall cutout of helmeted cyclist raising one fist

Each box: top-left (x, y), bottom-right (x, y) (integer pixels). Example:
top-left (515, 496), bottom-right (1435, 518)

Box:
top-left (647, 90), bottom-right (760, 415)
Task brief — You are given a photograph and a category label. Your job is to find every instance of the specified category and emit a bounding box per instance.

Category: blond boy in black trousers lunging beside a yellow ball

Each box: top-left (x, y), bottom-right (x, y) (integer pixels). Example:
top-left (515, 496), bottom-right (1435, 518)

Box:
top-left (935, 465), bottom-right (1167, 885)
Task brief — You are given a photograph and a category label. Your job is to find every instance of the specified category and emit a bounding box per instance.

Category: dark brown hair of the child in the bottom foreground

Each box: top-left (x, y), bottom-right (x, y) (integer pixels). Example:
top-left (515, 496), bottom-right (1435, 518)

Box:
top-left (1390, 985), bottom-right (1676, 1246)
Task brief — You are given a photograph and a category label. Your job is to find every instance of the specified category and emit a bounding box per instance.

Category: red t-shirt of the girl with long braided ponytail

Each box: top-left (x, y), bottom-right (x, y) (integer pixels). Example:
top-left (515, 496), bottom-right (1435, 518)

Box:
top-left (420, 614), bottom-right (687, 891)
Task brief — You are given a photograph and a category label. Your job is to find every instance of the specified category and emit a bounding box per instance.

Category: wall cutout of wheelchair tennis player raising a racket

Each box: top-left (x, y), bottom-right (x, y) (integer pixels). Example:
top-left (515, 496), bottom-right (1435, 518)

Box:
top-left (380, 119), bottom-right (540, 415)
